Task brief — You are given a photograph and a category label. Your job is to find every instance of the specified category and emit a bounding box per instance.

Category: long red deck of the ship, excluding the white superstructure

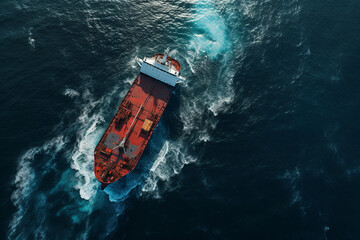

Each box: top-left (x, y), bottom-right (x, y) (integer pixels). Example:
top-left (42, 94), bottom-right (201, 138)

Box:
top-left (94, 72), bottom-right (174, 185)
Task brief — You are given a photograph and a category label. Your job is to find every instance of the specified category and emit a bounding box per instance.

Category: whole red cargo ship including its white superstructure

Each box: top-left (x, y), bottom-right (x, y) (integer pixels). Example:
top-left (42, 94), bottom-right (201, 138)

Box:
top-left (94, 49), bottom-right (185, 189)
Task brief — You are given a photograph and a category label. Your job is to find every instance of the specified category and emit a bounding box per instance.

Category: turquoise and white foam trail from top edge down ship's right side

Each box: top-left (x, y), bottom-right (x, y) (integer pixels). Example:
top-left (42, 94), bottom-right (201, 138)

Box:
top-left (141, 0), bottom-right (238, 198)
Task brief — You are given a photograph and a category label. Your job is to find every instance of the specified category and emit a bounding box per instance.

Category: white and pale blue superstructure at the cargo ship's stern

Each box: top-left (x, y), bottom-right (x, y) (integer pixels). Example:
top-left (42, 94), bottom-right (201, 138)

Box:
top-left (136, 49), bottom-right (185, 87)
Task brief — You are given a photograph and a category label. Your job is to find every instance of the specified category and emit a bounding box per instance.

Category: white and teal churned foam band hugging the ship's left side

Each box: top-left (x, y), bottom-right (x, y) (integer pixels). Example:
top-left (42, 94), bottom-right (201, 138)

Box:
top-left (45, 87), bottom-right (122, 236)
